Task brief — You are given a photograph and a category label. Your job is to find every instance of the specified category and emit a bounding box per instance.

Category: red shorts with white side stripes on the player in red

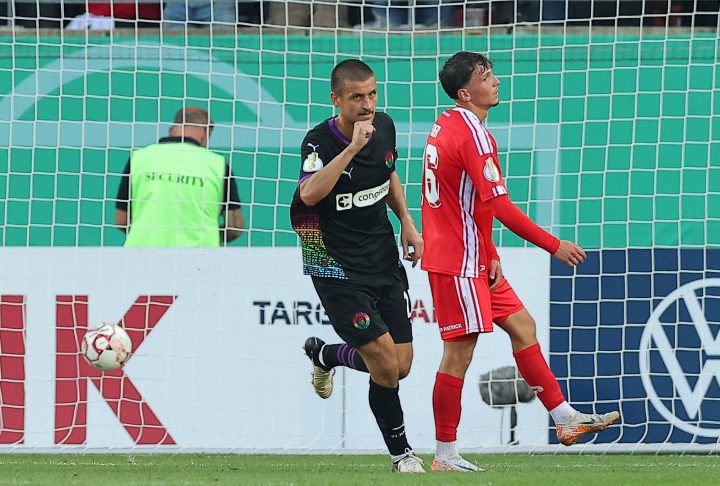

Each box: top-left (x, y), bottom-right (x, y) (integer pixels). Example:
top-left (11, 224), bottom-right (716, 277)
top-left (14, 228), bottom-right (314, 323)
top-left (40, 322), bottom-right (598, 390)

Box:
top-left (428, 272), bottom-right (524, 341)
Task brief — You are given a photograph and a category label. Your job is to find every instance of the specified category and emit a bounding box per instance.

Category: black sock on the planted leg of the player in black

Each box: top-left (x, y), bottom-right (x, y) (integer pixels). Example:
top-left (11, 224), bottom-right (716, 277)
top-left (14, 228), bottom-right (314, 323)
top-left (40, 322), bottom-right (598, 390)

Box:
top-left (368, 378), bottom-right (410, 456)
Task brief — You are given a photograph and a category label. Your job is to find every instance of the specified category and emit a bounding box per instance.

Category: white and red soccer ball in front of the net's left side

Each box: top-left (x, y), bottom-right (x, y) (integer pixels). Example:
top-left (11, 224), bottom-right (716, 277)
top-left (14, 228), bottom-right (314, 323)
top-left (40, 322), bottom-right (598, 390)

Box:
top-left (80, 322), bottom-right (132, 371)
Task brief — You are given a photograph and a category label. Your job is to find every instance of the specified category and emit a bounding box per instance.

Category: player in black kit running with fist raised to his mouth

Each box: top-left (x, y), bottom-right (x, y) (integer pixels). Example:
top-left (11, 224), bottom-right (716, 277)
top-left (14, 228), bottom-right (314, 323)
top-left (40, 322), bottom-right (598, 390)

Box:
top-left (290, 59), bottom-right (425, 473)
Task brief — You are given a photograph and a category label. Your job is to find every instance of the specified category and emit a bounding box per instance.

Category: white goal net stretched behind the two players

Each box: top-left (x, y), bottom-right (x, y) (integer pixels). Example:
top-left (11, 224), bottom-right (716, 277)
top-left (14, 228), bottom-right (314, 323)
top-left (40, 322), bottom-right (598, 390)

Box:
top-left (0, 0), bottom-right (720, 453)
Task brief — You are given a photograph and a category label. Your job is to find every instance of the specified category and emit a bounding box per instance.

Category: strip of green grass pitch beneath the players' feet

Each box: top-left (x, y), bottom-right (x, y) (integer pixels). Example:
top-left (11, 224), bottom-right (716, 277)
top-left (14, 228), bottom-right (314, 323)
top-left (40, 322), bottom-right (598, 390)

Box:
top-left (0, 454), bottom-right (720, 486)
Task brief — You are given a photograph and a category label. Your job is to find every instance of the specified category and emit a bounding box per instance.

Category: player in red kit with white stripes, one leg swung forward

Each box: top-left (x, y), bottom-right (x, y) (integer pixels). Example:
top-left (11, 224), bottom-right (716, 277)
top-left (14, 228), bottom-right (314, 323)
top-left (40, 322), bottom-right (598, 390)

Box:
top-left (422, 51), bottom-right (620, 472)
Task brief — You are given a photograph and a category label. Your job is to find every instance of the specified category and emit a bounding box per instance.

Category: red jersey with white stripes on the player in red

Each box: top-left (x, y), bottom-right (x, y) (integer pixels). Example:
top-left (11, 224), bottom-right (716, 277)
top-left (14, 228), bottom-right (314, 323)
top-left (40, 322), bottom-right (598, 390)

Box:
top-left (422, 106), bottom-right (507, 278)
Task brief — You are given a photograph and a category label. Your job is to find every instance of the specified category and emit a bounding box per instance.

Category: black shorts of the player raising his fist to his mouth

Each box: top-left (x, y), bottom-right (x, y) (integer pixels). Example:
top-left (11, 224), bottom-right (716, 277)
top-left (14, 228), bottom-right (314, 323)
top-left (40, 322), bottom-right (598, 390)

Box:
top-left (312, 267), bottom-right (412, 347)
